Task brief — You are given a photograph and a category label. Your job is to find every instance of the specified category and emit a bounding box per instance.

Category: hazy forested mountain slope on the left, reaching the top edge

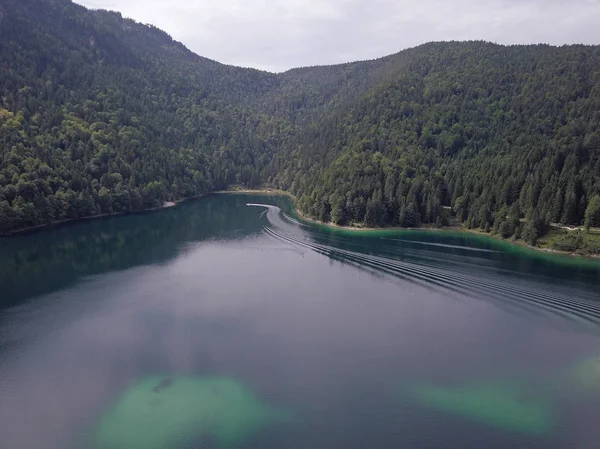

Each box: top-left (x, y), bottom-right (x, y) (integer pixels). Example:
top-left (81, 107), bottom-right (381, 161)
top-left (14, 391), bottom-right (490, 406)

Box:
top-left (0, 0), bottom-right (276, 231)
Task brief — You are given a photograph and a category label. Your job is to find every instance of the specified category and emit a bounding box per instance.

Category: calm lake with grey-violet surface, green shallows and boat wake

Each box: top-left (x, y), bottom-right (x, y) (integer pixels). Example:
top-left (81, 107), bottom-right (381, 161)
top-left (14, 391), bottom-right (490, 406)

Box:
top-left (0, 195), bottom-right (600, 449)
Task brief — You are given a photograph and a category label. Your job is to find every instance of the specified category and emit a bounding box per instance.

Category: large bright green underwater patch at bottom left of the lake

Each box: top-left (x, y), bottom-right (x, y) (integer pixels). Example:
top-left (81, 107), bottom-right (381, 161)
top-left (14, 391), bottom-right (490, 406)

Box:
top-left (94, 377), bottom-right (285, 449)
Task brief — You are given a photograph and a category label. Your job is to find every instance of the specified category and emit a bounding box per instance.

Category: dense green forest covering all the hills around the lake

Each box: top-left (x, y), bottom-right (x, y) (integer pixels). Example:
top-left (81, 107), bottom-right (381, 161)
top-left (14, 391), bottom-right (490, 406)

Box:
top-left (0, 0), bottom-right (600, 251)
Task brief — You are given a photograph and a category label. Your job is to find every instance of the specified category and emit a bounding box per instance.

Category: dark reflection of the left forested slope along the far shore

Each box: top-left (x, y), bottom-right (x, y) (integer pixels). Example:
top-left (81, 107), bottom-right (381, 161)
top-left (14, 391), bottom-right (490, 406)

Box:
top-left (0, 195), bottom-right (289, 307)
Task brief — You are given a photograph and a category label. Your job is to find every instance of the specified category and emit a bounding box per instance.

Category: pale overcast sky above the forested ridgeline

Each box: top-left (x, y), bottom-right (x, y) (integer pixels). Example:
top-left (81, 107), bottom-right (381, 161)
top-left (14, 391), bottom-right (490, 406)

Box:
top-left (76, 0), bottom-right (600, 71)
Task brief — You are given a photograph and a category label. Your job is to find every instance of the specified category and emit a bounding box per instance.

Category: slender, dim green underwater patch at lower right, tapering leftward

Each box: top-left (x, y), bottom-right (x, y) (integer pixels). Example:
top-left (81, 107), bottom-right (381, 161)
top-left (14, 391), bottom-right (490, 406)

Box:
top-left (408, 384), bottom-right (553, 435)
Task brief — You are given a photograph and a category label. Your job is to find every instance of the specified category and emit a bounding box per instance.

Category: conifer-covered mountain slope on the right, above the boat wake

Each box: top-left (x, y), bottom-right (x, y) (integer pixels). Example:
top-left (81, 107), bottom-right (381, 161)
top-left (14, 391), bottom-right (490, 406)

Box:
top-left (275, 43), bottom-right (600, 238)
